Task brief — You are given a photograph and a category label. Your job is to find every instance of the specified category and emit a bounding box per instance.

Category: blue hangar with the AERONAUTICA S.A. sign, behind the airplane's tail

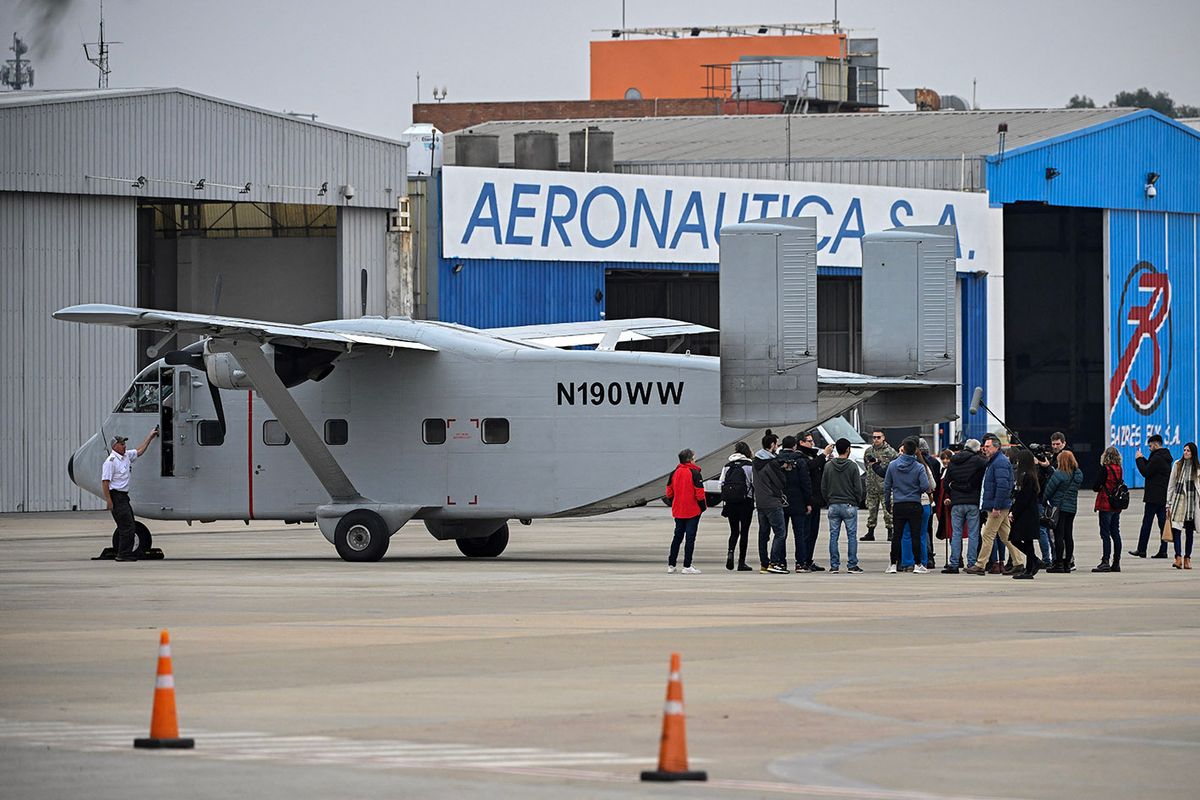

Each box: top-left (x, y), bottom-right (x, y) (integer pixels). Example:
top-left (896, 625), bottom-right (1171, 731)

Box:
top-left (415, 109), bottom-right (1200, 485)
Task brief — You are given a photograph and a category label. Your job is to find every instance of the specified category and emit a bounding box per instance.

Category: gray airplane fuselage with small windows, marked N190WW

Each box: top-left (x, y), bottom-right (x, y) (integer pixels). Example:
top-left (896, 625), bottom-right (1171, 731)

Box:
top-left (72, 319), bottom-right (757, 534)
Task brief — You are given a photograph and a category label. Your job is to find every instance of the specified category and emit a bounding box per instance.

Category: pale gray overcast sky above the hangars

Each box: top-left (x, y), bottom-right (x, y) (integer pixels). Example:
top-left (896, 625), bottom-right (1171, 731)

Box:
top-left (0, 0), bottom-right (1200, 136)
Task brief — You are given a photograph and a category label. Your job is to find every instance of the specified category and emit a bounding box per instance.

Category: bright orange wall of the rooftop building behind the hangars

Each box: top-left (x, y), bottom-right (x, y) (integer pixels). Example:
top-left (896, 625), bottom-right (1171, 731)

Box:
top-left (592, 34), bottom-right (847, 100)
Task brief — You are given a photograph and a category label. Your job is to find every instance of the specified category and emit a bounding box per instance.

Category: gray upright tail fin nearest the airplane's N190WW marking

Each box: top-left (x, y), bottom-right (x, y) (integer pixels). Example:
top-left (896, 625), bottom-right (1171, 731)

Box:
top-left (720, 217), bottom-right (817, 428)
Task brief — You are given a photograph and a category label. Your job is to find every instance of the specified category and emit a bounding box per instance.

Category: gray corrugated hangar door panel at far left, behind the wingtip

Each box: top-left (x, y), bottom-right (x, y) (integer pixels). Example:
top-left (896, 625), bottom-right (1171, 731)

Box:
top-left (0, 192), bottom-right (137, 511)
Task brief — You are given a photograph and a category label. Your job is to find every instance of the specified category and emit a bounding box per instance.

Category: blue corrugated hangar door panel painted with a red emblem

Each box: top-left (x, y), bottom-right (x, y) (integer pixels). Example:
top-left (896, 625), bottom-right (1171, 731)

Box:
top-left (1105, 211), bottom-right (1200, 486)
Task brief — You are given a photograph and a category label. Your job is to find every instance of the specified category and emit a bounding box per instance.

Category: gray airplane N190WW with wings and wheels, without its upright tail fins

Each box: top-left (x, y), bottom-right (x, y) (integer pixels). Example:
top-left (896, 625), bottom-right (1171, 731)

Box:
top-left (54, 215), bottom-right (954, 561)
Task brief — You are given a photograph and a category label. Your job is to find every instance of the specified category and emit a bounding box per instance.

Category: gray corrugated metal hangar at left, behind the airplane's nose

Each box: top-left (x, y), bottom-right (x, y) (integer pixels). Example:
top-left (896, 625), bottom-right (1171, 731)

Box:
top-left (0, 89), bottom-right (412, 511)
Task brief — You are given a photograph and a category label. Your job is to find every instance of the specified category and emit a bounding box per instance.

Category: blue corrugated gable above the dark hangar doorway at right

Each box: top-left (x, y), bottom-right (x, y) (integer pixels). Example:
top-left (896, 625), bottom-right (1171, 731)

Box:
top-left (988, 109), bottom-right (1200, 213)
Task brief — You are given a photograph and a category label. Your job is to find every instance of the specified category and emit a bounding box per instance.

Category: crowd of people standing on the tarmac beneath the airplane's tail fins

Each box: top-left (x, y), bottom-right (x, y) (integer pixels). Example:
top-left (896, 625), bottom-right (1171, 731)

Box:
top-left (665, 431), bottom-right (1200, 579)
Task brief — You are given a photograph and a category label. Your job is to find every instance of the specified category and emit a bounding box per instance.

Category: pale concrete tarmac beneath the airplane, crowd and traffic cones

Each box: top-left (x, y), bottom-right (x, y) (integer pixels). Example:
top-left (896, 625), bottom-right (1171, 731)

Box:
top-left (0, 493), bottom-right (1200, 800)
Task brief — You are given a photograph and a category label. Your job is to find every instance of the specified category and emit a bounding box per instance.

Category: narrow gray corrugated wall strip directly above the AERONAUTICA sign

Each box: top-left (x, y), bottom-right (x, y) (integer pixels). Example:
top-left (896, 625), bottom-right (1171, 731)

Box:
top-left (616, 156), bottom-right (985, 192)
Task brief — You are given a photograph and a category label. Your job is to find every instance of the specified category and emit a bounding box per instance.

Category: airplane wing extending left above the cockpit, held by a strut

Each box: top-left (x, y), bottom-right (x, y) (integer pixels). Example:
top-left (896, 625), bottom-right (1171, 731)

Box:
top-left (54, 303), bottom-right (437, 353)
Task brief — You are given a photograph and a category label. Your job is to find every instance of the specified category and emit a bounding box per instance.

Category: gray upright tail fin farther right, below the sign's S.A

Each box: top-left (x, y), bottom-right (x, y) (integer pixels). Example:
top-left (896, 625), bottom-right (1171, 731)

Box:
top-left (863, 225), bottom-right (958, 427)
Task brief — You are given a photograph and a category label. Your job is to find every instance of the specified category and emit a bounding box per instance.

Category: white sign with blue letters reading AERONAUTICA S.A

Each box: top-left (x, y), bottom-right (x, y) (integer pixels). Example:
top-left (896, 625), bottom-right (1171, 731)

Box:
top-left (442, 167), bottom-right (1002, 270)
